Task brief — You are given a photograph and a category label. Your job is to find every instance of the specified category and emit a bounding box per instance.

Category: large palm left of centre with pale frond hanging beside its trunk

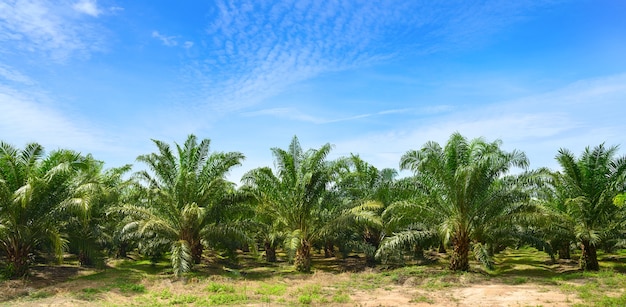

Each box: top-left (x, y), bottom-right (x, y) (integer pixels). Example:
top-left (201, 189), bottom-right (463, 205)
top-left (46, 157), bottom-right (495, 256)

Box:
top-left (119, 135), bottom-right (244, 276)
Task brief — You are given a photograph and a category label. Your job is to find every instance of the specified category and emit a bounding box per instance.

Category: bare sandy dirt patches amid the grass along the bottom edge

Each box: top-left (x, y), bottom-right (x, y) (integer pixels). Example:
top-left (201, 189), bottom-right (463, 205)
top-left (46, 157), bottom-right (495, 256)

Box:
top-left (0, 267), bottom-right (580, 307)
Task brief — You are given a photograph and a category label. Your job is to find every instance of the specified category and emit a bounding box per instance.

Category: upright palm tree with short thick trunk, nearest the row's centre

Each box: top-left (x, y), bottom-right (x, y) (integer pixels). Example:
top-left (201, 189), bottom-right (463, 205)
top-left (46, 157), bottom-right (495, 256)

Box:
top-left (242, 136), bottom-right (333, 272)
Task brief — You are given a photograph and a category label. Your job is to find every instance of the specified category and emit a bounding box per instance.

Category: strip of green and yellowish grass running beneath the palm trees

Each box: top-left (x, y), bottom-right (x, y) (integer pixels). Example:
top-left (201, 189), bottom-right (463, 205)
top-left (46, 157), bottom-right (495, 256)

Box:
top-left (0, 248), bottom-right (626, 306)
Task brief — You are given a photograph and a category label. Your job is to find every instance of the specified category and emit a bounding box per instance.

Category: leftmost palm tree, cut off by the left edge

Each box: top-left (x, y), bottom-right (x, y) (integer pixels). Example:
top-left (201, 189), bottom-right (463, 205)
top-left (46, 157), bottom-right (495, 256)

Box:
top-left (0, 142), bottom-right (85, 277)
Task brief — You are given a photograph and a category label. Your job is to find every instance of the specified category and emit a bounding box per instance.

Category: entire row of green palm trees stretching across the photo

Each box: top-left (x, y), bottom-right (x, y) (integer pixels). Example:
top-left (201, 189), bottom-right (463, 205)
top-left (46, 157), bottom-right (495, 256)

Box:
top-left (0, 133), bottom-right (626, 277)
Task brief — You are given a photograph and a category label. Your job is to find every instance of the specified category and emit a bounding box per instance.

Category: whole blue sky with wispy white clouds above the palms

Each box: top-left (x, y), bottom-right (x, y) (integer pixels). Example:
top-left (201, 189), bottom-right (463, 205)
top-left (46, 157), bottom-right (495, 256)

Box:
top-left (0, 0), bottom-right (626, 181)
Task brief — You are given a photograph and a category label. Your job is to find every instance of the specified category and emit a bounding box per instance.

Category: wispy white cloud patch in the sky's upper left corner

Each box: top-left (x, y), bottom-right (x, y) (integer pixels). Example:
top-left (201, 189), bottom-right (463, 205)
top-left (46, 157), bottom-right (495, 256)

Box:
top-left (0, 0), bottom-right (102, 62)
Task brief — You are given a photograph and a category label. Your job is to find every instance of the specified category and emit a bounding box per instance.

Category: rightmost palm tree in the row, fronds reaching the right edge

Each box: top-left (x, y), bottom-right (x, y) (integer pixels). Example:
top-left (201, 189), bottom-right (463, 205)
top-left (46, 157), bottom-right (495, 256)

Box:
top-left (552, 144), bottom-right (626, 271)
